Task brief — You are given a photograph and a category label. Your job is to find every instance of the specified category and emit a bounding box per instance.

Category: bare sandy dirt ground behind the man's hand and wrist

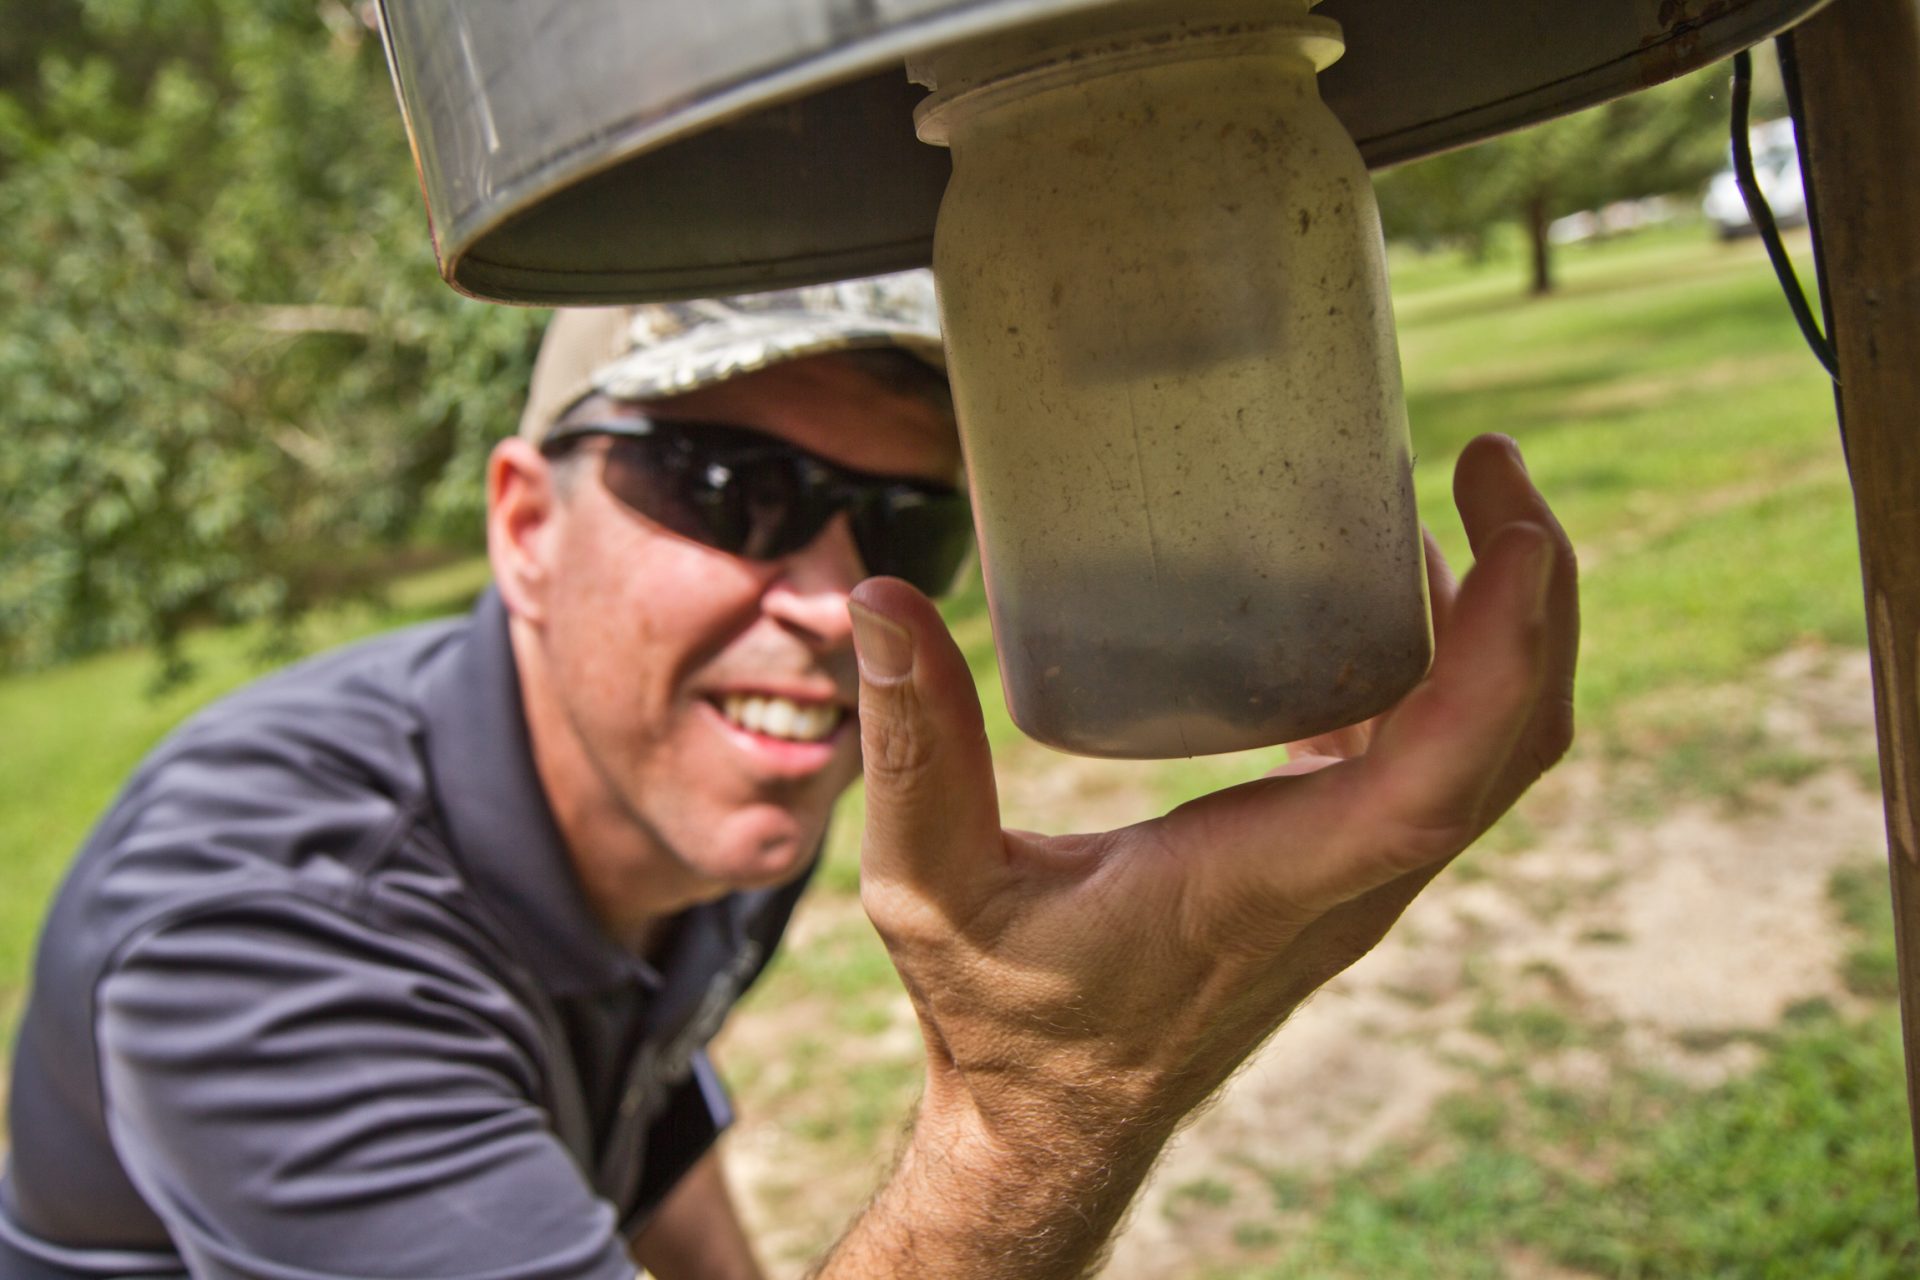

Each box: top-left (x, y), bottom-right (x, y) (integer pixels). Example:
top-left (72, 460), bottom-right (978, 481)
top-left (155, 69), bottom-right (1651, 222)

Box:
top-left (733, 651), bottom-right (1884, 1280)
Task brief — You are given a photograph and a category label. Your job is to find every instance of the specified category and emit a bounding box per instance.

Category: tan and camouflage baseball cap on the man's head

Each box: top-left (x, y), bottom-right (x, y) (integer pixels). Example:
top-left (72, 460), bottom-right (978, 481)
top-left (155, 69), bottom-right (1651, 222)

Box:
top-left (520, 271), bottom-right (947, 443)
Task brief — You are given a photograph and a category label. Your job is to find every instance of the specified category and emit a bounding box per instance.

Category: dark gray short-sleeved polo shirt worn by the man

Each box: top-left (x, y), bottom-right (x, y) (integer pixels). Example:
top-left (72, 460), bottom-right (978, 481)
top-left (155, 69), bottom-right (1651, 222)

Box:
top-left (0, 593), bottom-right (801, 1280)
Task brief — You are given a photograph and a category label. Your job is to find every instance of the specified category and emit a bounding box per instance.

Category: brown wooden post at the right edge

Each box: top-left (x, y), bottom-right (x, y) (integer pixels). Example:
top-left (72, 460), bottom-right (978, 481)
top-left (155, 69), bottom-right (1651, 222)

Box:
top-left (1793, 0), bottom-right (1920, 1205)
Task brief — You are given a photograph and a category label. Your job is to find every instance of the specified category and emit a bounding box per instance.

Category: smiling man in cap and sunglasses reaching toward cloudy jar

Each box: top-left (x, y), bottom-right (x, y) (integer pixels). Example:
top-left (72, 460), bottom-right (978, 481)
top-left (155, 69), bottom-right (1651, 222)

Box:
top-left (0, 270), bottom-right (1576, 1280)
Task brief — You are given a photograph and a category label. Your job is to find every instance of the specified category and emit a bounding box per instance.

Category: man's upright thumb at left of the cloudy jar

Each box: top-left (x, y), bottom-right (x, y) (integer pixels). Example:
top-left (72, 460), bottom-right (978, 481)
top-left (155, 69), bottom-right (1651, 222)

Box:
top-left (849, 578), bottom-right (1000, 890)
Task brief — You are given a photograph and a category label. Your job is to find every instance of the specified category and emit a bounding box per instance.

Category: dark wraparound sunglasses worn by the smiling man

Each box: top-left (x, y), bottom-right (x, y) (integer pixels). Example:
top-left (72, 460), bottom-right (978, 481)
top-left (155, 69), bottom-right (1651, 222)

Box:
top-left (540, 418), bottom-right (973, 595)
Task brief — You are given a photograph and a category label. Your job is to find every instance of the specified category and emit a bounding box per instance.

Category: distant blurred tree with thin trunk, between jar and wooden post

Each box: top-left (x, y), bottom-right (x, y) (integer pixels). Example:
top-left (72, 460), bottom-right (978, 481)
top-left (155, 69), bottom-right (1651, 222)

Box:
top-left (1377, 67), bottom-right (1751, 294)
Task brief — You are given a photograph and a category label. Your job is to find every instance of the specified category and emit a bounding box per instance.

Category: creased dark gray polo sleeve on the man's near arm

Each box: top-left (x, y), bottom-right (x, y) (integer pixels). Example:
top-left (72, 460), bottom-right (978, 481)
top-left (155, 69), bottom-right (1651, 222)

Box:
top-left (96, 894), bottom-right (634, 1280)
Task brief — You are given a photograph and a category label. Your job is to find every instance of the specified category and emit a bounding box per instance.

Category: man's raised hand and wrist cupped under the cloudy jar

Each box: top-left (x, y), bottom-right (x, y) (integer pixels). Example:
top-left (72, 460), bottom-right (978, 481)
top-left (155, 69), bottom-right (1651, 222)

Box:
top-left (824, 436), bottom-right (1578, 1280)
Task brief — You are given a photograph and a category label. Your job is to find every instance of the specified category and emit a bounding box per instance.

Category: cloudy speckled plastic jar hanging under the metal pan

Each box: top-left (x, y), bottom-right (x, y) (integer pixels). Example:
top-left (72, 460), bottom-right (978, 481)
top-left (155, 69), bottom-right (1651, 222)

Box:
top-left (914, 0), bottom-right (1432, 758)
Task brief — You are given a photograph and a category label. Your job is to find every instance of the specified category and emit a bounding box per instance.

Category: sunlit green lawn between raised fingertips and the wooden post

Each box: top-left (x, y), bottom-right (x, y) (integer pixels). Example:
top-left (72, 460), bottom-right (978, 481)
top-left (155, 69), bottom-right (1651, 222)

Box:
top-left (1402, 227), bottom-right (1864, 722)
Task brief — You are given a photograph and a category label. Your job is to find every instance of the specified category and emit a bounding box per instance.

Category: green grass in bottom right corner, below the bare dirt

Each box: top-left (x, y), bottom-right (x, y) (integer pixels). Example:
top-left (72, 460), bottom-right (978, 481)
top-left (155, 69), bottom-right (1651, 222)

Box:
top-left (1213, 1007), bottom-right (1920, 1280)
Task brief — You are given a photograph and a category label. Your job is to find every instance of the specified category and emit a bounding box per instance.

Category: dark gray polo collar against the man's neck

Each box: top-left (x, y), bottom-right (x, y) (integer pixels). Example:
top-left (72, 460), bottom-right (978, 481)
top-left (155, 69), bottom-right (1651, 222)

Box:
top-left (420, 587), bottom-right (659, 996)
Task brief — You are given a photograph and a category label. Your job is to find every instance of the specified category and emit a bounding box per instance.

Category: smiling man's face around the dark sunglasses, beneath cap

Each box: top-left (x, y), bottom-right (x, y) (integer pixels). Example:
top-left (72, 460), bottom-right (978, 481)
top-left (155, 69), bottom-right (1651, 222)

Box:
top-left (506, 355), bottom-right (960, 921)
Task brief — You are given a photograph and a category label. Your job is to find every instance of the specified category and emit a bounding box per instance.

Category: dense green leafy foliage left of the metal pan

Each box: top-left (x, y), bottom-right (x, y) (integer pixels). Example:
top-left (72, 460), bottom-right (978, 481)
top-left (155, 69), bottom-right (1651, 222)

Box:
top-left (0, 0), bottom-right (540, 679)
